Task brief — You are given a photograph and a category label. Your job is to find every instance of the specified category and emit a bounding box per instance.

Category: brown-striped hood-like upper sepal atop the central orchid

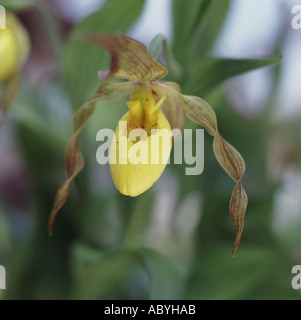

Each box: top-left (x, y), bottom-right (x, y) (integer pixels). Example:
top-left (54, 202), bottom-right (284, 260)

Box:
top-left (87, 34), bottom-right (168, 82)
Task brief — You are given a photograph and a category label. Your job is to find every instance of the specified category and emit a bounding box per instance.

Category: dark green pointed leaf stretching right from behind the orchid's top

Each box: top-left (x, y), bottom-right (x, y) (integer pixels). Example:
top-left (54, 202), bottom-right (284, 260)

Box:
top-left (183, 56), bottom-right (281, 97)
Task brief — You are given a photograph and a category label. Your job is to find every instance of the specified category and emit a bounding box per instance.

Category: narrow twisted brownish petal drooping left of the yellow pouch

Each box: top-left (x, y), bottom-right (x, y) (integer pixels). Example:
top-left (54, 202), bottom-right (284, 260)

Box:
top-left (48, 82), bottom-right (138, 234)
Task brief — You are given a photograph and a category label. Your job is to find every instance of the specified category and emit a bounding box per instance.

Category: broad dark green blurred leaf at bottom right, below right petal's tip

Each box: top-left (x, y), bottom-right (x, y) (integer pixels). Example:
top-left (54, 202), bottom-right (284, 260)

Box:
top-left (184, 246), bottom-right (300, 300)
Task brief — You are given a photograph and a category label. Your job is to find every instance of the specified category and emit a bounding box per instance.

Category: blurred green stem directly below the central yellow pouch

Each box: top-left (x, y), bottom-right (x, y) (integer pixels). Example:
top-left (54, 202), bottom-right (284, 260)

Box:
top-left (124, 190), bottom-right (153, 249)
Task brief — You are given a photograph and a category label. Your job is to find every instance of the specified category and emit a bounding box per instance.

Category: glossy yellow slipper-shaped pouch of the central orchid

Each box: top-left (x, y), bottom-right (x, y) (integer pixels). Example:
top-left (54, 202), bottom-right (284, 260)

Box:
top-left (110, 84), bottom-right (172, 197)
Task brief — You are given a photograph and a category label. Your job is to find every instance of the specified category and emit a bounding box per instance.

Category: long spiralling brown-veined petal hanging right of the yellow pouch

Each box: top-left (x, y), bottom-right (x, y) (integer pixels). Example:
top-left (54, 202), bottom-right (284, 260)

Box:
top-left (155, 83), bottom-right (248, 256)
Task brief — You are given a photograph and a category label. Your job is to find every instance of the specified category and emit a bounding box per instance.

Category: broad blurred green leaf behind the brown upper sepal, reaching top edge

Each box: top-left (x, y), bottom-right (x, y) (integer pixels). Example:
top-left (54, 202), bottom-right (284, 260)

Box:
top-left (63, 0), bottom-right (144, 108)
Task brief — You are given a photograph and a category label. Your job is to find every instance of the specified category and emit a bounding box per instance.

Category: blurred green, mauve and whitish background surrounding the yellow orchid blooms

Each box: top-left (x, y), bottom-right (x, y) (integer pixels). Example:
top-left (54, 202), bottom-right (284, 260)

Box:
top-left (0, 0), bottom-right (301, 299)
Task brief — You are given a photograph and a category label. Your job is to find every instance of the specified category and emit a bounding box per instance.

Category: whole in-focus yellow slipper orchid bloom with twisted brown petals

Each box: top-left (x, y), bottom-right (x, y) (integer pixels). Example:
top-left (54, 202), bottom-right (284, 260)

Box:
top-left (49, 35), bottom-right (248, 255)
